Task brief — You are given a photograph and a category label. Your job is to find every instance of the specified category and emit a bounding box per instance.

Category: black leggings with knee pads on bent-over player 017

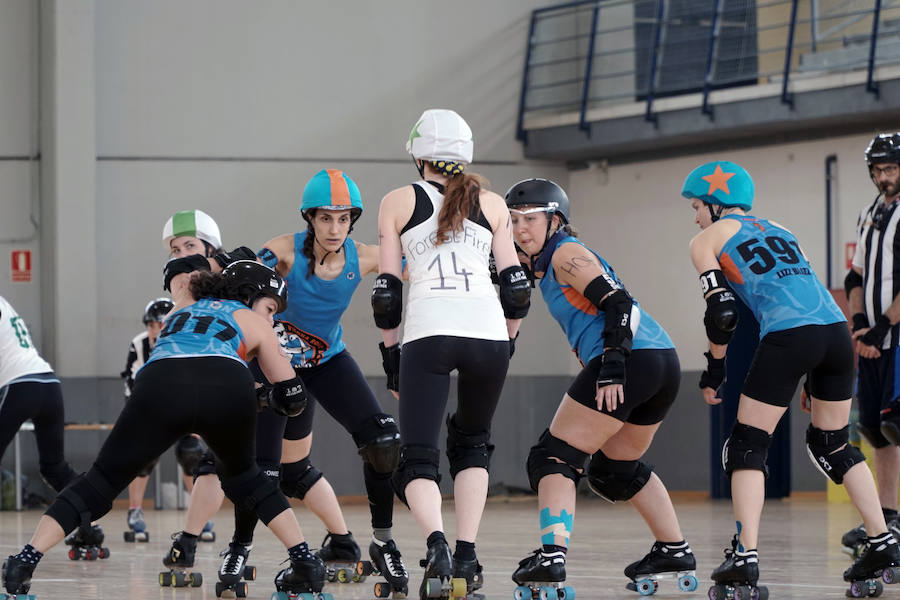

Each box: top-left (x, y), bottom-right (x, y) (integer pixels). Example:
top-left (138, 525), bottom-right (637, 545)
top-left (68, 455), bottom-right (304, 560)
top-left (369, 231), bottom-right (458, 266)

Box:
top-left (47, 357), bottom-right (289, 532)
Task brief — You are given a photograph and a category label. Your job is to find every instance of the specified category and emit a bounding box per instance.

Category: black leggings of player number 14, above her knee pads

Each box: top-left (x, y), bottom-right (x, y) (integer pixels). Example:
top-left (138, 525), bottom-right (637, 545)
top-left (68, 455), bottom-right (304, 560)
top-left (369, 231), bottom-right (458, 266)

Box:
top-left (400, 335), bottom-right (509, 448)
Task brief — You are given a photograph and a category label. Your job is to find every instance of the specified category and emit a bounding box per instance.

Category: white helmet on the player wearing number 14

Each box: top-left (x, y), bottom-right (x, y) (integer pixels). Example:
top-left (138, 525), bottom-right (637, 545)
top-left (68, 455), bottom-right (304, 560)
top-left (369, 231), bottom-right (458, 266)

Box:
top-left (406, 108), bottom-right (473, 164)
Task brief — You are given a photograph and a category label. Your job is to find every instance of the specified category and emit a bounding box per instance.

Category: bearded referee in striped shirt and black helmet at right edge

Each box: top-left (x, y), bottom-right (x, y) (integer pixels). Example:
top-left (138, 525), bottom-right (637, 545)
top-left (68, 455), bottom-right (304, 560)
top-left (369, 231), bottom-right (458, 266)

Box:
top-left (841, 133), bottom-right (900, 555)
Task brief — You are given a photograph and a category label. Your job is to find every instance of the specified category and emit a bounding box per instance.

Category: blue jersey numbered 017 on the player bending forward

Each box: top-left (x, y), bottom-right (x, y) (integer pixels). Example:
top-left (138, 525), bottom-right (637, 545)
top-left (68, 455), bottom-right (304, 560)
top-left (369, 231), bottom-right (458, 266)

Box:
top-left (141, 298), bottom-right (247, 369)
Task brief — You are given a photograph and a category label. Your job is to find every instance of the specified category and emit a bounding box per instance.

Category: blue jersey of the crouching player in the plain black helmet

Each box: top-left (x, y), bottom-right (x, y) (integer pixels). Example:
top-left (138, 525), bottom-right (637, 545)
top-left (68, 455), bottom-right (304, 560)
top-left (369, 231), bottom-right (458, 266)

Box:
top-left (540, 236), bottom-right (675, 364)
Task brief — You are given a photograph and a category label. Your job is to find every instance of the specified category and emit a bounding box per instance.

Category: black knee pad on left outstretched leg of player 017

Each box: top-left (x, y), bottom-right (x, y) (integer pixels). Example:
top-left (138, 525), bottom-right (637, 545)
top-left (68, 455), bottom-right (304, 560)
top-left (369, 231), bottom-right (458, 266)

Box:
top-left (46, 467), bottom-right (122, 534)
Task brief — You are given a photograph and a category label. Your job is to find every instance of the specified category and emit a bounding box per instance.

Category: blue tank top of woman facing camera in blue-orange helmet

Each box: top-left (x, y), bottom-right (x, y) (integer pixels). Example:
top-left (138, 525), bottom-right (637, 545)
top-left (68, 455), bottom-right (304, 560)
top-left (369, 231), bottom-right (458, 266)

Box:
top-left (268, 231), bottom-right (361, 368)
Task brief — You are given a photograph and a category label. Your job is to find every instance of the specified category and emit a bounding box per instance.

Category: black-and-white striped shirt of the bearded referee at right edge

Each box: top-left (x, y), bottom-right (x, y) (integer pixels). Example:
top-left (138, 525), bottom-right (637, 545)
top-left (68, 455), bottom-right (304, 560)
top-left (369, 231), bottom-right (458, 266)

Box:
top-left (853, 195), bottom-right (900, 348)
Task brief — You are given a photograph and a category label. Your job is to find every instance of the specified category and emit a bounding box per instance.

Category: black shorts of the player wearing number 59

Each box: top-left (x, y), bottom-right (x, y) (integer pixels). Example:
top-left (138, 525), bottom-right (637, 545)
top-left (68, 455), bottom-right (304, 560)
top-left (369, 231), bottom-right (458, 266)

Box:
top-left (742, 321), bottom-right (853, 406)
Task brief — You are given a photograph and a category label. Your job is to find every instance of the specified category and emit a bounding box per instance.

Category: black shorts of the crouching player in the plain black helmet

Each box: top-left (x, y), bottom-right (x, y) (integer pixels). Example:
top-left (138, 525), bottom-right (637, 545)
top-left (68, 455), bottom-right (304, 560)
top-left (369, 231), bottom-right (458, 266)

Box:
top-left (569, 348), bottom-right (681, 425)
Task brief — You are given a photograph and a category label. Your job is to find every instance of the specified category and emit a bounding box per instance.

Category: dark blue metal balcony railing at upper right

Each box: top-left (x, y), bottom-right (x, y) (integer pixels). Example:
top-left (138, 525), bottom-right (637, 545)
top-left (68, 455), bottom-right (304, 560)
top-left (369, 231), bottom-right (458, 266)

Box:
top-left (517, 0), bottom-right (900, 140)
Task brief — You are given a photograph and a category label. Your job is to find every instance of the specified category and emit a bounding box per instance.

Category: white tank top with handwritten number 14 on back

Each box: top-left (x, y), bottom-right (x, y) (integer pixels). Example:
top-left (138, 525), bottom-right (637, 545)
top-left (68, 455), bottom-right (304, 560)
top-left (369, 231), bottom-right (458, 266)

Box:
top-left (400, 181), bottom-right (509, 343)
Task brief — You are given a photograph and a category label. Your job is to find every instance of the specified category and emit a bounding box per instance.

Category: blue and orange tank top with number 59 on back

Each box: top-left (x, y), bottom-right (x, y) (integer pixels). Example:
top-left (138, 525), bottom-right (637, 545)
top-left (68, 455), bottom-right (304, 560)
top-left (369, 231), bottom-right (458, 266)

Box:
top-left (719, 215), bottom-right (846, 338)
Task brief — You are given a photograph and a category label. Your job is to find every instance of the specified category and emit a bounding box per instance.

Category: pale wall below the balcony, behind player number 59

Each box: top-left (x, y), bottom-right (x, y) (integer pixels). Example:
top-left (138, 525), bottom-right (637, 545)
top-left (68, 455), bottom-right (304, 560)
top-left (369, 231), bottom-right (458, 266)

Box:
top-left (568, 132), bottom-right (884, 370)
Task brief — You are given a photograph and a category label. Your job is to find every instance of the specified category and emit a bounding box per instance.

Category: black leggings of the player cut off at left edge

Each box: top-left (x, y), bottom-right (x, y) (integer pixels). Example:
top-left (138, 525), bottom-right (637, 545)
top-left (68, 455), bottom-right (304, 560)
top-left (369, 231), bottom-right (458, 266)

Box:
top-left (0, 373), bottom-right (75, 492)
